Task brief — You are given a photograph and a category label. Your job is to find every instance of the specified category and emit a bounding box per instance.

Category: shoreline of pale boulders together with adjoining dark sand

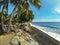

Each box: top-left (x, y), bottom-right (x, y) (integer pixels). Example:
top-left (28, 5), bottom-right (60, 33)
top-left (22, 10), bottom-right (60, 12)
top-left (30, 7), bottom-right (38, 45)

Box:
top-left (0, 27), bottom-right (60, 45)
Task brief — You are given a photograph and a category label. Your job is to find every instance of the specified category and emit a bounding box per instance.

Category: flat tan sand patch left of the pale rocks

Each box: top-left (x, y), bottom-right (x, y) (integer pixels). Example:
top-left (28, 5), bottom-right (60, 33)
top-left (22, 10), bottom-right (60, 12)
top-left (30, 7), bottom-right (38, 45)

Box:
top-left (0, 33), bottom-right (15, 45)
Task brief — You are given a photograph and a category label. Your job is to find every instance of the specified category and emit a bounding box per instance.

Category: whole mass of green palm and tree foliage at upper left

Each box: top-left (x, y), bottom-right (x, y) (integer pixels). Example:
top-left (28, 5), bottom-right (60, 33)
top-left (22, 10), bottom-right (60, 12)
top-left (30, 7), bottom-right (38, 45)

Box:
top-left (0, 0), bottom-right (41, 22)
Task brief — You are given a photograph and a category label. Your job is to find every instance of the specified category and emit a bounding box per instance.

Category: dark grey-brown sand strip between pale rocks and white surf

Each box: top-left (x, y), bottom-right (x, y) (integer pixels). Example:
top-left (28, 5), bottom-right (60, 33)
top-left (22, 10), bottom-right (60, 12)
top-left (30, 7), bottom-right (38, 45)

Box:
top-left (30, 24), bottom-right (60, 45)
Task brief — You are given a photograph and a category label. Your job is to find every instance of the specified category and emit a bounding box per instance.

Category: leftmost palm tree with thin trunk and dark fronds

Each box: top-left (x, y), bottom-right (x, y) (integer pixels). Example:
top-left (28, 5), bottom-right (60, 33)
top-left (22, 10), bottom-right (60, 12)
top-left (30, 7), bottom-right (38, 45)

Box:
top-left (0, 0), bottom-right (8, 31)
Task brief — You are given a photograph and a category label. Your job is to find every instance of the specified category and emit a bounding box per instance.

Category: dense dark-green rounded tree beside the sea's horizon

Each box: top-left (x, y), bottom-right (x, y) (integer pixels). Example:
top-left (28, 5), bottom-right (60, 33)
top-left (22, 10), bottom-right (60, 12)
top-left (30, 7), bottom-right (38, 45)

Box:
top-left (17, 10), bottom-right (34, 22)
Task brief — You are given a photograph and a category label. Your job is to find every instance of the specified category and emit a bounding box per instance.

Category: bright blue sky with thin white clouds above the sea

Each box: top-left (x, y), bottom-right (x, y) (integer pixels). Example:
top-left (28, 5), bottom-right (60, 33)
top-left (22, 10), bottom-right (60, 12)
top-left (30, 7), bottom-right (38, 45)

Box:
top-left (8, 0), bottom-right (60, 22)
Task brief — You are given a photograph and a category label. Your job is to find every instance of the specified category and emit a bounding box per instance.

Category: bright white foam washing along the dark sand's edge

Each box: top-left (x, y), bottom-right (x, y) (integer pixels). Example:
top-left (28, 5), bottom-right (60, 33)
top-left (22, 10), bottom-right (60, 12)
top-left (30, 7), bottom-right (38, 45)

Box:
top-left (31, 24), bottom-right (60, 41)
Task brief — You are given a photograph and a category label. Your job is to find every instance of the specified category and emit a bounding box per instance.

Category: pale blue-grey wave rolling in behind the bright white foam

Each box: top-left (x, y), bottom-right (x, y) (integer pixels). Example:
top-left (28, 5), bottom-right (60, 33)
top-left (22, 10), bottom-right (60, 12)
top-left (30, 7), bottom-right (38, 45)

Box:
top-left (31, 24), bottom-right (60, 34)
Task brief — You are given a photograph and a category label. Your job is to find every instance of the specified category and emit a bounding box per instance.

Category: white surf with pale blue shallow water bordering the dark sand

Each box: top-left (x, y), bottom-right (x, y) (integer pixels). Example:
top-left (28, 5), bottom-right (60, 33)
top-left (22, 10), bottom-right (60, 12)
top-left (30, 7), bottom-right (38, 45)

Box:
top-left (31, 24), bottom-right (60, 41)
